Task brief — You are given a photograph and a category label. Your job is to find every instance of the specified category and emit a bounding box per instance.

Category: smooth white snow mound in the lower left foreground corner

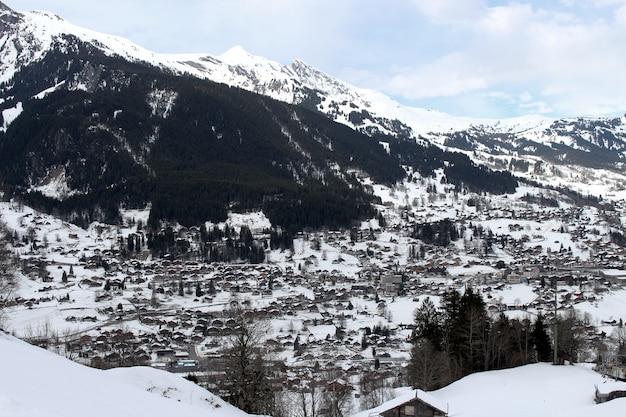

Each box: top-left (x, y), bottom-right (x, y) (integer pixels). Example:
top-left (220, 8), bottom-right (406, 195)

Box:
top-left (0, 333), bottom-right (254, 417)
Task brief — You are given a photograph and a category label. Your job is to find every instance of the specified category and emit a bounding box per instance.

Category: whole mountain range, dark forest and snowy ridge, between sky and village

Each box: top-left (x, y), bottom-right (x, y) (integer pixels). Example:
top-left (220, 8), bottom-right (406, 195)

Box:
top-left (0, 3), bottom-right (626, 231)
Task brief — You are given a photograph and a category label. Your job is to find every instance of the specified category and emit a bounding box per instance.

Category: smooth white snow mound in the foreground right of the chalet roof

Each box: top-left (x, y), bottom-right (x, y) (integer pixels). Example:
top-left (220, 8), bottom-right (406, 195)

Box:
top-left (431, 363), bottom-right (626, 417)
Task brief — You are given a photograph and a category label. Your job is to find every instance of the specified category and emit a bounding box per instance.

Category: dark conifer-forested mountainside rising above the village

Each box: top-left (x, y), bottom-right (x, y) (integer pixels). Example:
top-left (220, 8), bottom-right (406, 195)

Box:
top-left (0, 31), bottom-right (517, 231)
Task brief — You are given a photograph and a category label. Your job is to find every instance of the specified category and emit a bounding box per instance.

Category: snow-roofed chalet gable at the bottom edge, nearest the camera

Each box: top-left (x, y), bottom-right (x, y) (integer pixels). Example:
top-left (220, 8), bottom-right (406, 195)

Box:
top-left (352, 389), bottom-right (448, 417)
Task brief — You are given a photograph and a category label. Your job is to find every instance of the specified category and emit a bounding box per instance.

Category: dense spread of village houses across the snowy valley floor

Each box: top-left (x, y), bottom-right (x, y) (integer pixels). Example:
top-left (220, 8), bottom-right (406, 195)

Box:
top-left (2, 196), bottom-right (626, 416)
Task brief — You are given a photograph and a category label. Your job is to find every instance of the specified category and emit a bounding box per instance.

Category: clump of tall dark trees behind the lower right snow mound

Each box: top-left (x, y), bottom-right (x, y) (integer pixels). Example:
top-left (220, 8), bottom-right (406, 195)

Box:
top-left (408, 288), bottom-right (583, 390)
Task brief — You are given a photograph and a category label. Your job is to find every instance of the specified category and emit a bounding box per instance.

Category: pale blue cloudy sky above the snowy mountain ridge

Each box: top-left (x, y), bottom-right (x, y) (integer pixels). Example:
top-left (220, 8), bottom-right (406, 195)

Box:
top-left (4, 0), bottom-right (626, 118)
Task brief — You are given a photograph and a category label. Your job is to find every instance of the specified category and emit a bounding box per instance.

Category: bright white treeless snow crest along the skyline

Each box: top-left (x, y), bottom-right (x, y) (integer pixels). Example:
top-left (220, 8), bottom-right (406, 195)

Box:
top-left (3, 5), bottom-right (623, 140)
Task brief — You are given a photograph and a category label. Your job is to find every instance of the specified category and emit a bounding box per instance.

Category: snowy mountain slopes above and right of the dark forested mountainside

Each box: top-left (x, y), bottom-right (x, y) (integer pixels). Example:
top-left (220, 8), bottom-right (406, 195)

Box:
top-left (0, 3), bottom-right (626, 202)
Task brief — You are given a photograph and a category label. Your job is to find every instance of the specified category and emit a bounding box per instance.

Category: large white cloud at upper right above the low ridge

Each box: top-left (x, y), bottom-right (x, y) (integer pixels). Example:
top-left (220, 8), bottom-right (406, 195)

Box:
top-left (372, 1), bottom-right (626, 115)
